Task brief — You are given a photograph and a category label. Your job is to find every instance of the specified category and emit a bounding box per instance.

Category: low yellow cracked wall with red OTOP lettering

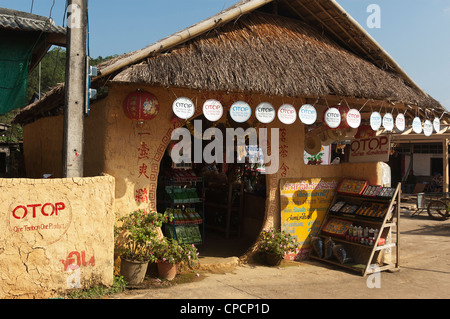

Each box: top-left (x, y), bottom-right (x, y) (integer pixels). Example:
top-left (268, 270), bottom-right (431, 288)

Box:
top-left (0, 176), bottom-right (115, 299)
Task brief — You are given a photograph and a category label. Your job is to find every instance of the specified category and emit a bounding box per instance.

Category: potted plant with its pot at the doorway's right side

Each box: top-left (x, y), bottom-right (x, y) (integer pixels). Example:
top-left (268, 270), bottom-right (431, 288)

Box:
top-left (260, 228), bottom-right (298, 266)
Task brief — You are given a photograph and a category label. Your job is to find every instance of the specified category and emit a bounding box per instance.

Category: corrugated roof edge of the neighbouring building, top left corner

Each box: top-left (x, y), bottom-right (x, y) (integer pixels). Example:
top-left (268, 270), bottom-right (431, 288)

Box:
top-left (0, 8), bottom-right (66, 34)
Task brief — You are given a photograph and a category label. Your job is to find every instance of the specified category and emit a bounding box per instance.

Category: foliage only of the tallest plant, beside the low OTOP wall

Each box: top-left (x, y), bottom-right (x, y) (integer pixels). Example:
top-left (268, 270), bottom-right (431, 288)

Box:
top-left (115, 210), bottom-right (173, 262)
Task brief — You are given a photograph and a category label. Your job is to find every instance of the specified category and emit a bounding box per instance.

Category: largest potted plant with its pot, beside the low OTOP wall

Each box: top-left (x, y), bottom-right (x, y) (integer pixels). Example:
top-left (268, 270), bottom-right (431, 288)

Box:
top-left (115, 210), bottom-right (172, 285)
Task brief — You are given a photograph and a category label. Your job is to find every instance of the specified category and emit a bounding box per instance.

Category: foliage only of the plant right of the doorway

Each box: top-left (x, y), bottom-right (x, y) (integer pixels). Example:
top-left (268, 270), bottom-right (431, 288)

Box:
top-left (260, 228), bottom-right (298, 256)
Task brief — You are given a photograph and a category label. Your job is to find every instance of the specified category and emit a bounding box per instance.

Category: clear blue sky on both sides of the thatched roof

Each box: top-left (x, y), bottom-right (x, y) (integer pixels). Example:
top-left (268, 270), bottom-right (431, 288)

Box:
top-left (0, 0), bottom-right (450, 110)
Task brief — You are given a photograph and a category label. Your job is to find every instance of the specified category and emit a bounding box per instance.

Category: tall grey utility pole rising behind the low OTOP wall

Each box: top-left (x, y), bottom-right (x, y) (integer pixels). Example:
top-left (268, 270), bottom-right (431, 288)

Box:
top-left (62, 0), bottom-right (87, 178)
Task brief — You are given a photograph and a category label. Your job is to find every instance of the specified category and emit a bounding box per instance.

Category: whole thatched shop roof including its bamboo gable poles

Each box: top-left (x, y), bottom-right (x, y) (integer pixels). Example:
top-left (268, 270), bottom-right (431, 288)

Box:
top-left (15, 0), bottom-right (444, 123)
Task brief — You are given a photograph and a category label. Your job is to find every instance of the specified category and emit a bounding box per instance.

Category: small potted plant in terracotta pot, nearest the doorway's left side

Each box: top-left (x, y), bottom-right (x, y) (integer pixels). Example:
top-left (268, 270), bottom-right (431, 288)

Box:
top-left (153, 237), bottom-right (198, 280)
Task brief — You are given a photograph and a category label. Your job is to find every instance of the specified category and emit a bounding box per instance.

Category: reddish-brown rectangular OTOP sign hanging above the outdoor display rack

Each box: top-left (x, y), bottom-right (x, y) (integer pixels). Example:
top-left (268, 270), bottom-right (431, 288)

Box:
top-left (349, 136), bottom-right (391, 163)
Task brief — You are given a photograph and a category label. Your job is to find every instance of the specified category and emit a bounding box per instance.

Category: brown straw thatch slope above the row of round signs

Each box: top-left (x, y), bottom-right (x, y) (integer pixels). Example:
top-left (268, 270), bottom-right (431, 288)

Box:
top-left (113, 13), bottom-right (439, 107)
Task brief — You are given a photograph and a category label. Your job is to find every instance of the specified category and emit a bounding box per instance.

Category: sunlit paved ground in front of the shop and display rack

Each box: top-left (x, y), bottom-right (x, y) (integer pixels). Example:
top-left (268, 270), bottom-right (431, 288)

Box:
top-left (113, 200), bottom-right (450, 299)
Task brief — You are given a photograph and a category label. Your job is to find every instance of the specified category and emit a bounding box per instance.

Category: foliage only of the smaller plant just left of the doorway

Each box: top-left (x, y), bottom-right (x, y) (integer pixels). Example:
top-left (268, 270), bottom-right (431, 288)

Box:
top-left (153, 237), bottom-right (198, 265)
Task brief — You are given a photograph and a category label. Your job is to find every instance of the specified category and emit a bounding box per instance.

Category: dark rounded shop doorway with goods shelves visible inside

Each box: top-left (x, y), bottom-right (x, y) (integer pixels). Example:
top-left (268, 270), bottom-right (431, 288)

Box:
top-left (157, 116), bottom-right (266, 257)
